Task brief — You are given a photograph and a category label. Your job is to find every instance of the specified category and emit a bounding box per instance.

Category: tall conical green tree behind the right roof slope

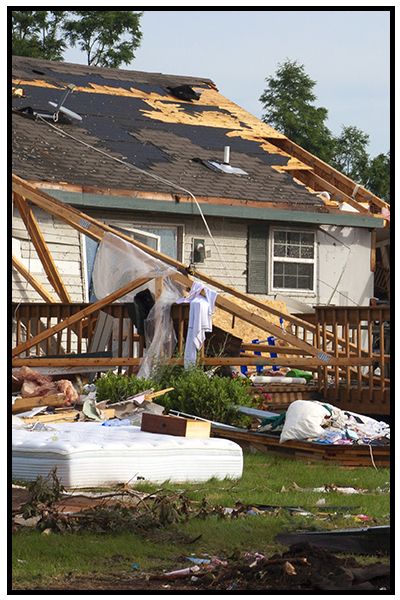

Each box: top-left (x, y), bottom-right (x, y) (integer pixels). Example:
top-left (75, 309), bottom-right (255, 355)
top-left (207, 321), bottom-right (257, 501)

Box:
top-left (260, 59), bottom-right (333, 162)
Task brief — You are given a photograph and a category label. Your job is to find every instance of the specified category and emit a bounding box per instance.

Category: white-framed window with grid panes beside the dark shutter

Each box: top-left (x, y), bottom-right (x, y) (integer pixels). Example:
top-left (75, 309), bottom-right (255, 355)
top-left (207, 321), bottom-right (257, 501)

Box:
top-left (271, 229), bottom-right (315, 292)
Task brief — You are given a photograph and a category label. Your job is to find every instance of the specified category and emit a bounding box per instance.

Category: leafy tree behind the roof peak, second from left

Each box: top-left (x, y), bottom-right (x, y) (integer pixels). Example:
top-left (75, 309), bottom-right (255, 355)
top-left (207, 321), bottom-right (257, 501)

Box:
top-left (63, 10), bottom-right (143, 68)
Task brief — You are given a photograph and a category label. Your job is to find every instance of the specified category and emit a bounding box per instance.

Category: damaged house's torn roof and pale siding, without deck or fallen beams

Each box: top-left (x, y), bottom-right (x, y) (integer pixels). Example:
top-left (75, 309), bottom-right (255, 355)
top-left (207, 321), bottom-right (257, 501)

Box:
top-left (12, 57), bottom-right (387, 312)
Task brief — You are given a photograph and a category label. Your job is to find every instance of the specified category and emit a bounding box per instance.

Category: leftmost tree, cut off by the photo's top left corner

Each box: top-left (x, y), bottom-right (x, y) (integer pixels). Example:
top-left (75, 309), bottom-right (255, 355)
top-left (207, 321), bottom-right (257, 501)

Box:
top-left (11, 10), bottom-right (66, 61)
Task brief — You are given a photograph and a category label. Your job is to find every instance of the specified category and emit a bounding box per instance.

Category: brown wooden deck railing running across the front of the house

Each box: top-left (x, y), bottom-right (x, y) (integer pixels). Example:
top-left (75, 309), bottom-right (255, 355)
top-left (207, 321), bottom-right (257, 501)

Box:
top-left (13, 302), bottom-right (390, 414)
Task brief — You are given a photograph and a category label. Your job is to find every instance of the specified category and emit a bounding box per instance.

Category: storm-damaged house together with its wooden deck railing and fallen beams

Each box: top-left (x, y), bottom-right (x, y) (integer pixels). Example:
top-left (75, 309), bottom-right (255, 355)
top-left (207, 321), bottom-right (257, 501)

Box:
top-left (12, 57), bottom-right (390, 414)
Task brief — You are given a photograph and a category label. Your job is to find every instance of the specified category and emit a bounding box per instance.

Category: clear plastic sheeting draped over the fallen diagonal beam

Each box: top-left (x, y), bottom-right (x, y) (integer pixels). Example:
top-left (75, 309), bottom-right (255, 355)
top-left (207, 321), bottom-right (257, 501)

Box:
top-left (92, 232), bottom-right (183, 377)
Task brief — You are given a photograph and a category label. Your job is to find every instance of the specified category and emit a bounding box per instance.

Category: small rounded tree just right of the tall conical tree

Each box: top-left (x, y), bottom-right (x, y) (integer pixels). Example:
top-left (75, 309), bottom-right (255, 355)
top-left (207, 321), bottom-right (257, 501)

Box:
top-left (332, 125), bottom-right (369, 185)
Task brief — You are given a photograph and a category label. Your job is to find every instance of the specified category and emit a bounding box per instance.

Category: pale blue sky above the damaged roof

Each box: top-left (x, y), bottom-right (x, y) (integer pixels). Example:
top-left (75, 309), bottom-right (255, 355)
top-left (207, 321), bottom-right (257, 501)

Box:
top-left (65, 7), bottom-right (390, 156)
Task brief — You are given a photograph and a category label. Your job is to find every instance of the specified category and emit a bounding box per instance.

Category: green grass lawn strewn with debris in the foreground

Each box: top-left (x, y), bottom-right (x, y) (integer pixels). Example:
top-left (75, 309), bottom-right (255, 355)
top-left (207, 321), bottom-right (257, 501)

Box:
top-left (12, 452), bottom-right (389, 589)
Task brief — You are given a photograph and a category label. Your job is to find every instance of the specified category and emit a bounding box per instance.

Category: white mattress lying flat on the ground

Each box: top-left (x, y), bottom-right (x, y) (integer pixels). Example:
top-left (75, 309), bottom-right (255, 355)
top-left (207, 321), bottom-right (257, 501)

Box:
top-left (12, 422), bottom-right (243, 488)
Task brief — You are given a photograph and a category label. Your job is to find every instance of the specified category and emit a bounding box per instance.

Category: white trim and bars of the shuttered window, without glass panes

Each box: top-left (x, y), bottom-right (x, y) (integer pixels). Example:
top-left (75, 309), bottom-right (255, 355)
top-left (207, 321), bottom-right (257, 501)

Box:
top-left (268, 227), bottom-right (317, 297)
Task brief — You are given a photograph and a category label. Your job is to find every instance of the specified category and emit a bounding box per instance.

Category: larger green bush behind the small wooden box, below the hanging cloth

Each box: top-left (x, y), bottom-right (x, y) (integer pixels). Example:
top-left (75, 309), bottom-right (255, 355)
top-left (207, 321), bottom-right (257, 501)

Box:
top-left (155, 367), bottom-right (254, 426)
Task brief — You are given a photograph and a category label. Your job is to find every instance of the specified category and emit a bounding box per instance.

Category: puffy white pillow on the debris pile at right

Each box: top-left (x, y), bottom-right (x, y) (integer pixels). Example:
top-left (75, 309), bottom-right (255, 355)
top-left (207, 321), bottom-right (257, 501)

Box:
top-left (279, 400), bottom-right (331, 444)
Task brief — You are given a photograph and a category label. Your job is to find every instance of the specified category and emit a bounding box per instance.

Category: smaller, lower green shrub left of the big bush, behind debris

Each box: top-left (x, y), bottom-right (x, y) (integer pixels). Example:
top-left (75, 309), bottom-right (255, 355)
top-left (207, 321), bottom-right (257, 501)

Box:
top-left (95, 371), bottom-right (160, 404)
